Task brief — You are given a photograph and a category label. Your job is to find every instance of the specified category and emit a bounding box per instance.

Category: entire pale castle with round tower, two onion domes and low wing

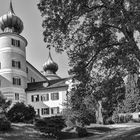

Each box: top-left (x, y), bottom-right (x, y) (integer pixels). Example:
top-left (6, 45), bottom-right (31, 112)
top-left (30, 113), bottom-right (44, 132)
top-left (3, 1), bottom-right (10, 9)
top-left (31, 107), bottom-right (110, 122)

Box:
top-left (0, 2), bottom-right (69, 117)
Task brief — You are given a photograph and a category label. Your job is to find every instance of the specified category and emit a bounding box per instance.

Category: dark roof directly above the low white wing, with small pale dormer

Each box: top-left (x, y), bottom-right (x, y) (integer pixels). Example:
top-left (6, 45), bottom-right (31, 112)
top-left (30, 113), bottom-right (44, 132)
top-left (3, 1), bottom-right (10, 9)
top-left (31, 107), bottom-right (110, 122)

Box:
top-left (26, 78), bottom-right (69, 92)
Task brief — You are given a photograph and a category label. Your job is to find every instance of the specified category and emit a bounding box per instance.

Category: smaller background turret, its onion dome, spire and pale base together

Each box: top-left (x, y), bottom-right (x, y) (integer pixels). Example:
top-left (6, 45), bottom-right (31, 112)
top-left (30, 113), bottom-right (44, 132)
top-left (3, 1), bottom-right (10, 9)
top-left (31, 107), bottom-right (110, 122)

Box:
top-left (43, 48), bottom-right (60, 80)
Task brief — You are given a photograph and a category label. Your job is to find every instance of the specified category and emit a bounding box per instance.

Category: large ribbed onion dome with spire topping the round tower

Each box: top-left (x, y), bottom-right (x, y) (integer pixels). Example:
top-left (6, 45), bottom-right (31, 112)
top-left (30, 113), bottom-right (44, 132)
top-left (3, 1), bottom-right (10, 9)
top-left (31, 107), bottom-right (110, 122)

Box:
top-left (0, 1), bottom-right (23, 34)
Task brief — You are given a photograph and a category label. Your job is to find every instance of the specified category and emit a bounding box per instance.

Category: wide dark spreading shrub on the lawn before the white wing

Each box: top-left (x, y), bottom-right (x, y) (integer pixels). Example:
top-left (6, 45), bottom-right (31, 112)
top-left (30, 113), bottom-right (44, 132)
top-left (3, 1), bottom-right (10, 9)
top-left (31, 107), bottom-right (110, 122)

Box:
top-left (35, 116), bottom-right (66, 137)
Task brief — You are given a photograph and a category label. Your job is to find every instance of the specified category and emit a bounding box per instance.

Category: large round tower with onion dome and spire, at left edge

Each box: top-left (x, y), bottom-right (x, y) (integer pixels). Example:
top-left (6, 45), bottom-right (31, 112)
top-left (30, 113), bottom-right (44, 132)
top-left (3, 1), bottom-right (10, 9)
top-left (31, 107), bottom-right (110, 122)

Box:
top-left (0, 1), bottom-right (27, 103)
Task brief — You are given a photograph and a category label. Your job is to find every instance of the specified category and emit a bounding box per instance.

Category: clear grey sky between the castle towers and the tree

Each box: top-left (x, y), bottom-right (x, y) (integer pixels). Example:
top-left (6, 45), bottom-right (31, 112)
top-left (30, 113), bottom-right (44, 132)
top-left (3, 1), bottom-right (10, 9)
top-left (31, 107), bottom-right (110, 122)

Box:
top-left (0, 0), bottom-right (69, 78)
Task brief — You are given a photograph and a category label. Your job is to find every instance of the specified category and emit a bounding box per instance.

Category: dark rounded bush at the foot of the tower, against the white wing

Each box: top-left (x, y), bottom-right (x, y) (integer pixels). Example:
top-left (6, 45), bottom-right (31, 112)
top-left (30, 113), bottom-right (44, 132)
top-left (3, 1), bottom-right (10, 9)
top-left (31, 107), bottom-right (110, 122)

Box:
top-left (7, 102), bottom-right (35, 123)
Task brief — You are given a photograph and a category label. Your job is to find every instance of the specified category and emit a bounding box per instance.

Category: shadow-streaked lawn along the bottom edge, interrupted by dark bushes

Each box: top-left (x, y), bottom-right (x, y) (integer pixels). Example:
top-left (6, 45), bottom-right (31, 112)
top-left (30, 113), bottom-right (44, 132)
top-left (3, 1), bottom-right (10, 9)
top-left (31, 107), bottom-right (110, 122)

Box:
top-left (0, 123), bottom-right (140, 140)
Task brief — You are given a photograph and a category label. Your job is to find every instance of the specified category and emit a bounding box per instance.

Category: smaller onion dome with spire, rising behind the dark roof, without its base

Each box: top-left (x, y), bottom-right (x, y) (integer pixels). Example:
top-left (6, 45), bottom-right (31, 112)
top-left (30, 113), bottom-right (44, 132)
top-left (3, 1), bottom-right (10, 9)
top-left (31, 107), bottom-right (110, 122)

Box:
top-left (43, 51), bottom-right (58, 74)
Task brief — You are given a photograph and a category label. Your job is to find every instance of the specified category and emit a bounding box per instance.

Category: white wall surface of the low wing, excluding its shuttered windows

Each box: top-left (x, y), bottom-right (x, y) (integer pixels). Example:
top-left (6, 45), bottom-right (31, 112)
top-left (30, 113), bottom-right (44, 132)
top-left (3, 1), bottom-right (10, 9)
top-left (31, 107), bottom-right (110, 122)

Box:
top-left (27, 87), bottom-right (67, 117)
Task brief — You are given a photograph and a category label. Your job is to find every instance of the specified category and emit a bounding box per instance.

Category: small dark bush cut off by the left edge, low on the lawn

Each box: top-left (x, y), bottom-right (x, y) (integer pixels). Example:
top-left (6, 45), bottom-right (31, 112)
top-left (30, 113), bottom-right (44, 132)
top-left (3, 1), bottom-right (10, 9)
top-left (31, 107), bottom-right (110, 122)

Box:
top-left (0, 119), bottom-right (11, 131)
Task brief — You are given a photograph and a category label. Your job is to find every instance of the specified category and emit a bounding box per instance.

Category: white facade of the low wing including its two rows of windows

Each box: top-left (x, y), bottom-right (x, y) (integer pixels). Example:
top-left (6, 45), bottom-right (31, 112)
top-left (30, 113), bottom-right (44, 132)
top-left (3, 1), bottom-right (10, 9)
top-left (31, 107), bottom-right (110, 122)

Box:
top-left (27, 88), bottom-right (67, 117)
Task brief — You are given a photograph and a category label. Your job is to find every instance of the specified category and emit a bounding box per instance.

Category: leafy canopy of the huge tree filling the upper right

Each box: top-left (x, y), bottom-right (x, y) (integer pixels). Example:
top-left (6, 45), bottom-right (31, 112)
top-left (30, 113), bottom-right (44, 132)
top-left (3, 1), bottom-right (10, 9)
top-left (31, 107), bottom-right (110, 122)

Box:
top-left (38, 0), bottom-right (140, 120)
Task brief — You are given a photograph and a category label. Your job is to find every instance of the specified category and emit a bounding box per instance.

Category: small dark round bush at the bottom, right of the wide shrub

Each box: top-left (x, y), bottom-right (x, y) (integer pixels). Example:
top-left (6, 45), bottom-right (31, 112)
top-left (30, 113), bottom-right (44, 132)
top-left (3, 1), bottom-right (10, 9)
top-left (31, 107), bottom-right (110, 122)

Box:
top-left (76, 126), bottom-right (88, 137)
